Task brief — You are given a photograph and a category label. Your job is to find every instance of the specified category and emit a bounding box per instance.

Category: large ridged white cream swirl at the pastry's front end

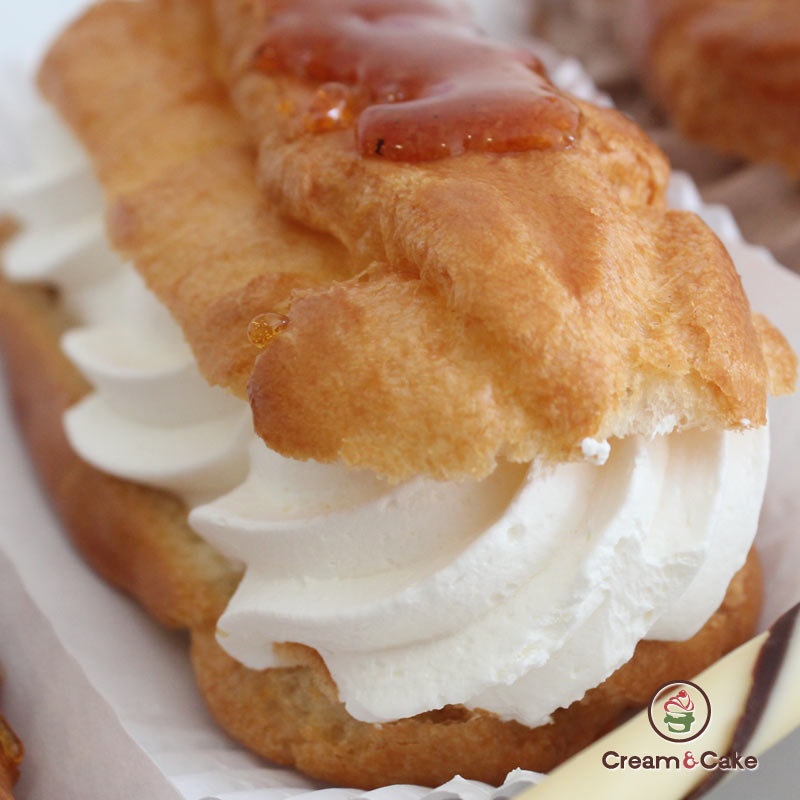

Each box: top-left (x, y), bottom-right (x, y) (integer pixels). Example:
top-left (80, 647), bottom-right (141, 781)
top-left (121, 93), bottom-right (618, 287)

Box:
top-left (190, 428), bottom-right (768, 725)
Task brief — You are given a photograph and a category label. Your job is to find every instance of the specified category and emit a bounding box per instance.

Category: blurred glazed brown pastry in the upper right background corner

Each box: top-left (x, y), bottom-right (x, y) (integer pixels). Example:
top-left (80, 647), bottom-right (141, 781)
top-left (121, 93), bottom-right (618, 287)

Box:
top-left (629, 0), bottom-right (800, 177)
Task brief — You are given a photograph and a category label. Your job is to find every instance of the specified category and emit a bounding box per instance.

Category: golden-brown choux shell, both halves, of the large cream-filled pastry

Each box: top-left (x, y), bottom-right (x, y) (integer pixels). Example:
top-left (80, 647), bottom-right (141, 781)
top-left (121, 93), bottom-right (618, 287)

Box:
top-left (0, 0), bottom-right (795, 787)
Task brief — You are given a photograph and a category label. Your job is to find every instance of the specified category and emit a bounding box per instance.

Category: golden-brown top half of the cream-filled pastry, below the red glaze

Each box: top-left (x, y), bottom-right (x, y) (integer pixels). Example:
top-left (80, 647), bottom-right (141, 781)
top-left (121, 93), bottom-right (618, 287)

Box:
top-left (36, 0), bottom-right (789, 479)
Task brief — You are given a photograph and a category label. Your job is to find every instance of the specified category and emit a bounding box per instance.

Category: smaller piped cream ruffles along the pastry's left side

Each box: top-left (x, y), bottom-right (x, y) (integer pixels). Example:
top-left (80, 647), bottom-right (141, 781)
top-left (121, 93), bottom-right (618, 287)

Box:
top-left (0, 98), bottom-right (252, 502)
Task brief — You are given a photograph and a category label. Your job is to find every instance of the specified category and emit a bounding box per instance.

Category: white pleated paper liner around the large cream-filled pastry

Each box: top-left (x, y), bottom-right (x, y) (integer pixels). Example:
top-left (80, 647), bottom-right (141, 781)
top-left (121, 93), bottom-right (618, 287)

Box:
top-left (0, 6), bottom-right (800, 800)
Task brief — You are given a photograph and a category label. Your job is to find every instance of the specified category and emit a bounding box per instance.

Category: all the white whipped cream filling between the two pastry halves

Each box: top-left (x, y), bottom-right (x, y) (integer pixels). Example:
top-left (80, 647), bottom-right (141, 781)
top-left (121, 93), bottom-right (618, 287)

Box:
top-left (0, 97), bottom-right (769, 725)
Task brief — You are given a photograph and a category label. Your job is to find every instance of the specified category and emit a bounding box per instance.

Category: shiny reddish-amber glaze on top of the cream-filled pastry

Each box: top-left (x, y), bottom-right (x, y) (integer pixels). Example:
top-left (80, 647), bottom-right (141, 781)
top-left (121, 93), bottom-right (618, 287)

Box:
top-left (255, 0), bottom-right (580, 161)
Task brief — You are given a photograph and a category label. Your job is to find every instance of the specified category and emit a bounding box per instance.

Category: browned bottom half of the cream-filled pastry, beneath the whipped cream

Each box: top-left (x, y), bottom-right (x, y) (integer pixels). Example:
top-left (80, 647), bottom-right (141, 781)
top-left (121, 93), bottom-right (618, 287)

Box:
top-left (0, 270), bottom-right (761, 789)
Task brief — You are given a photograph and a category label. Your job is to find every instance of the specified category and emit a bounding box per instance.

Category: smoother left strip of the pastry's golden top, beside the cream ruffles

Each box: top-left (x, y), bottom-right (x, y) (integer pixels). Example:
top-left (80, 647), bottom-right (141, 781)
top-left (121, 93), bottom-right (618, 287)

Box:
top-left (40, 0), bottom-right (350, 395)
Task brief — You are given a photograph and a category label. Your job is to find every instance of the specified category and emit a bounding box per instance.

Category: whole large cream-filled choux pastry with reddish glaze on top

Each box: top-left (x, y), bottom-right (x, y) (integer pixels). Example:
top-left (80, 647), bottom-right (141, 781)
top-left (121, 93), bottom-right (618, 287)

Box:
top-left (0, 0), bottom-right (796, 787)
